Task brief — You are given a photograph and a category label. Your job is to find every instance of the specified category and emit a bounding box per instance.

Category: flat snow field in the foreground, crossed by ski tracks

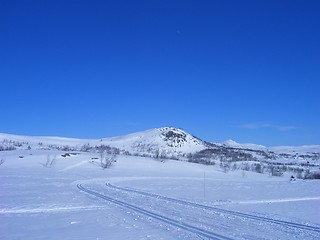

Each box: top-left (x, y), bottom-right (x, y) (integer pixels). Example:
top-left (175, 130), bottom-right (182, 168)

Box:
top-left (0, 150), bottom-right (320, 240)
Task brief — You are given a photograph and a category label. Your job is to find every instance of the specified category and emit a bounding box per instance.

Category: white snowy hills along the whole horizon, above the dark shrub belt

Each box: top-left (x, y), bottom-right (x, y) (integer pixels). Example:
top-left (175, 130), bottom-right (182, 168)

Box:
top-left (0, 127), bottom-right (320, 159)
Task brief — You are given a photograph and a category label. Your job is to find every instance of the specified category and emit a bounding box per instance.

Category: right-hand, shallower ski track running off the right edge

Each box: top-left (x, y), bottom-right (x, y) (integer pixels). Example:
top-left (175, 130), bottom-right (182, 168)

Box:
top-left (106, 183), bottom-right (320, 233)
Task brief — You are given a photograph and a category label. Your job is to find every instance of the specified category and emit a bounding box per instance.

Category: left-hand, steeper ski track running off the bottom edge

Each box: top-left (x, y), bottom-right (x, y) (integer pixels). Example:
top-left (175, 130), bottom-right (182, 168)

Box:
top-left (77, 184), bottom-right (232, 240)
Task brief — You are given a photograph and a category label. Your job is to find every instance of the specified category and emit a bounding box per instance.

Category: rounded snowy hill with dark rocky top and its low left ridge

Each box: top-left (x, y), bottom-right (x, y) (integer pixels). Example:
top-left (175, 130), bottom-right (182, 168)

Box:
top-left (0, 127), bottom-right (206, 158)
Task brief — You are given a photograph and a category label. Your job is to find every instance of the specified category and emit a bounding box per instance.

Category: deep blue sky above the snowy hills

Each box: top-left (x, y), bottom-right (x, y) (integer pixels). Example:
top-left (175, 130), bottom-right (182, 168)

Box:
top-left (0, 0), bottom-right (320, 146)
